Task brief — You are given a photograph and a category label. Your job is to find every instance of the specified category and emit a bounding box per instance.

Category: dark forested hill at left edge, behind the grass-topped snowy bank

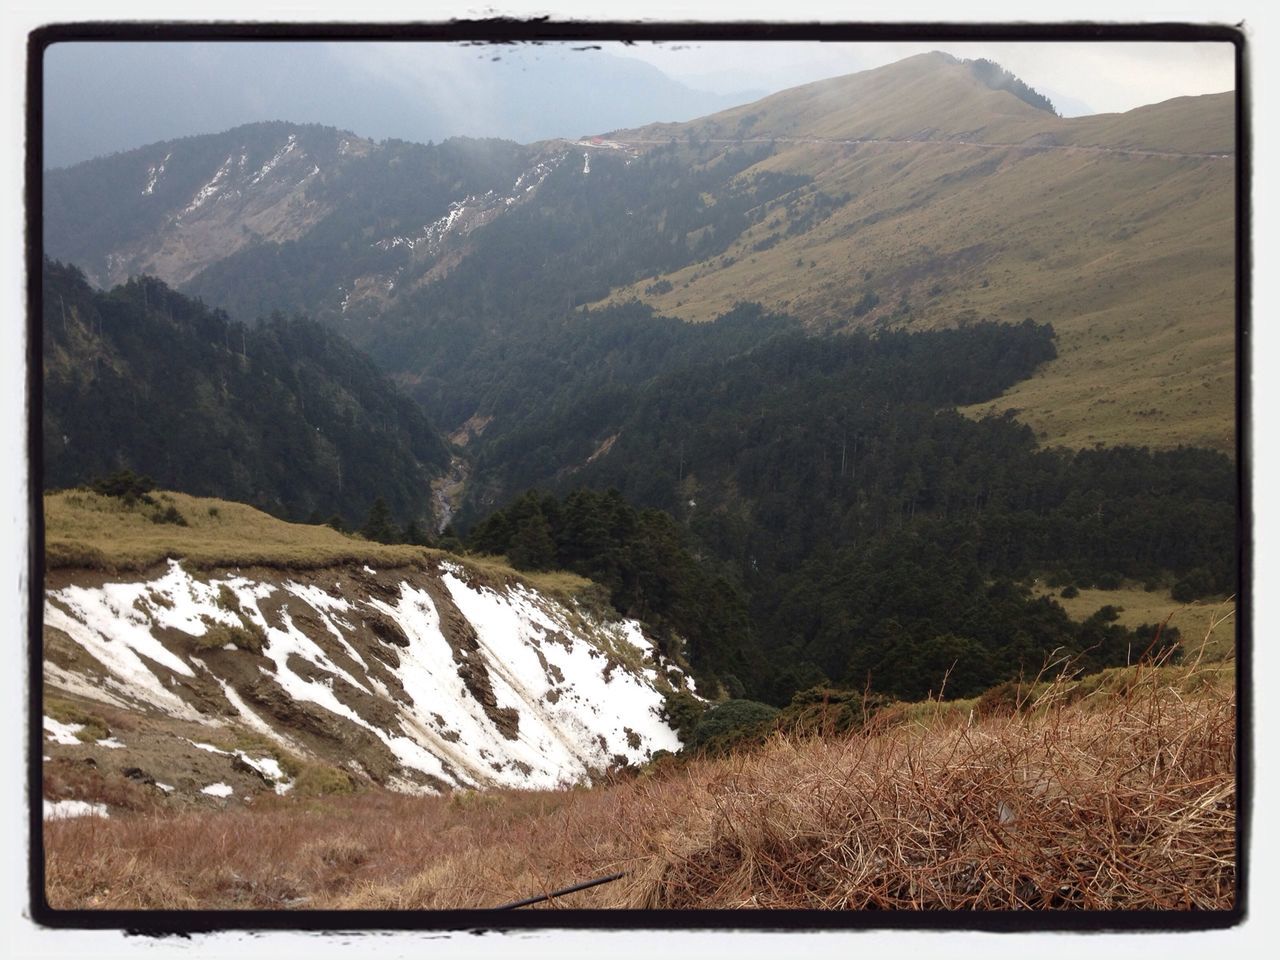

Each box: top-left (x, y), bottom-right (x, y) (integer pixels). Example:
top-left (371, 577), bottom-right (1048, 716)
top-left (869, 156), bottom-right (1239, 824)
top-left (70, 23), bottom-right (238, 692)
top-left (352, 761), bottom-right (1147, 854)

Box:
top-left (42, 261), bottom-right (449, 525)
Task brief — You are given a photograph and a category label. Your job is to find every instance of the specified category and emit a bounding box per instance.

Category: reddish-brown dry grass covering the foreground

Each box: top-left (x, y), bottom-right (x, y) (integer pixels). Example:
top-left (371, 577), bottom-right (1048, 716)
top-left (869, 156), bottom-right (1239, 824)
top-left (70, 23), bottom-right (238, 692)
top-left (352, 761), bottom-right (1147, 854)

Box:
top-left (45, 669), bottom-right (1235, 910)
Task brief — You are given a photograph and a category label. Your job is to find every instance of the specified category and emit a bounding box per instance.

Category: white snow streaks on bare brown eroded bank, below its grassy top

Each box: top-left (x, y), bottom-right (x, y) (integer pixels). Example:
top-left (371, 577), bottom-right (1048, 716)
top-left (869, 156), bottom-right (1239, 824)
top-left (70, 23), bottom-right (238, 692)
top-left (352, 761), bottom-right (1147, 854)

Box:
top-left (45, 561), bottom-right (690, 792)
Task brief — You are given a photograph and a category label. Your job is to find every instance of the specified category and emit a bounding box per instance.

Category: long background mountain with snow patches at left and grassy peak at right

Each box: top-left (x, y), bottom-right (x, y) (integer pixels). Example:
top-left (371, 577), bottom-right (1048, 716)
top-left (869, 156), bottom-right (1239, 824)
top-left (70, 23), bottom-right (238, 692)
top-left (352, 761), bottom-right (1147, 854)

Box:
top-left (45, 54), bottom-right (1235, 451)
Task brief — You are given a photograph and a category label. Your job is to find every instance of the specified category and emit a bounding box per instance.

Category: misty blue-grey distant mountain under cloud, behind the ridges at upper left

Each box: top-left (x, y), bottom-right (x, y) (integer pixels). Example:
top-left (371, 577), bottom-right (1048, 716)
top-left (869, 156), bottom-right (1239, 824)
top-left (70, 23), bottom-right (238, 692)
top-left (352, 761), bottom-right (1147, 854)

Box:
top-left (45, 42), bottom-right (754, 168)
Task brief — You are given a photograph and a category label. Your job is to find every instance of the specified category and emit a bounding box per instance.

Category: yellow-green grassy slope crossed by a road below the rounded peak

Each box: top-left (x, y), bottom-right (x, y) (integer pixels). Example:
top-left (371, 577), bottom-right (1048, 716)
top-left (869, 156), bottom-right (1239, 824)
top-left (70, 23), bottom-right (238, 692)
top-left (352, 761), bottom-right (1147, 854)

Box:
top-left (593, 55), bottom-right (1235, 452)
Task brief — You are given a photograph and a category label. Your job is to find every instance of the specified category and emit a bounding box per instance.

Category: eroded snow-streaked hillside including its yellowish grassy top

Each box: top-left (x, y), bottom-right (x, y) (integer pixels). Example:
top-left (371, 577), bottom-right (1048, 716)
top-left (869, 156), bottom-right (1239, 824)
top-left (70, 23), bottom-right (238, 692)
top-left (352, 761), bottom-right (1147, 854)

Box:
top-left (44, 492), bottom-right (691, 805)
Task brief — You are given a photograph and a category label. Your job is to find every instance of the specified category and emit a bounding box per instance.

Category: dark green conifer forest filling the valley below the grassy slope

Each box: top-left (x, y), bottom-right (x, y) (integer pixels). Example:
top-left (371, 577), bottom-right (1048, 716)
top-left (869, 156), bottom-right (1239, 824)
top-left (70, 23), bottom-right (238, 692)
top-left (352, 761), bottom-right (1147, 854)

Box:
top-left (463, 308), bottom-right (1236, 704)
